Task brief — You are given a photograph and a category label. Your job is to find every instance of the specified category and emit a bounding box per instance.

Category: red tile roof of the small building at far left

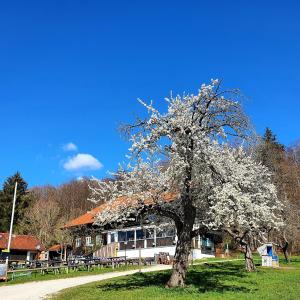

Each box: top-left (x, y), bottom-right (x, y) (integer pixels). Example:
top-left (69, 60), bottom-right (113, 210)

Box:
top-left (0, 233), bottom-right (45, 251)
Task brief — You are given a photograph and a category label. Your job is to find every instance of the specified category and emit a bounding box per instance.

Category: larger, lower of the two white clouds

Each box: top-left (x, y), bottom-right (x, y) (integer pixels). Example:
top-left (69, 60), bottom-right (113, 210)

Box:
top-left (63, 153), bottom-right (103, 171)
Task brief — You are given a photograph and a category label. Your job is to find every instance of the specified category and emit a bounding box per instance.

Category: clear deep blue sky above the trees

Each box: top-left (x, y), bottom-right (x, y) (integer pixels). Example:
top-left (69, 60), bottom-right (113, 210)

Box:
top-left (0, 0), bottom-right (300, 186)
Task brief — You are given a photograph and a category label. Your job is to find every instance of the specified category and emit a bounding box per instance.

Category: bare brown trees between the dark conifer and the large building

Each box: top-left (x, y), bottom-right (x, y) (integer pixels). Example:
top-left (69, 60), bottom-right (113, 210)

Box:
top-left (18, 179), bottom-right (93, 246)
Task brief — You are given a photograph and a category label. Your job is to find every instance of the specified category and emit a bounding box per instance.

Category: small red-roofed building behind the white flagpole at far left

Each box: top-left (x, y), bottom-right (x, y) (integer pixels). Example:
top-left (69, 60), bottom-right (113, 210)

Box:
top-left (0, 233), bottom-right (45, 261)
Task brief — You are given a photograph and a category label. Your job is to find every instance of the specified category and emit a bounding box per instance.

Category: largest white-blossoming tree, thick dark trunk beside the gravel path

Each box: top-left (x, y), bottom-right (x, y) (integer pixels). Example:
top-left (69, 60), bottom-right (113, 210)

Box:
top-left (91, 80), bottom-right (282, 287)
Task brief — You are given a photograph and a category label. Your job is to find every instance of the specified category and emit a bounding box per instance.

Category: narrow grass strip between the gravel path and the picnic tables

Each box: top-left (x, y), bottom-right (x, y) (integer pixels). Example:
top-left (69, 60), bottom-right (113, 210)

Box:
top-left (0, 266), bottom-right (144, 286)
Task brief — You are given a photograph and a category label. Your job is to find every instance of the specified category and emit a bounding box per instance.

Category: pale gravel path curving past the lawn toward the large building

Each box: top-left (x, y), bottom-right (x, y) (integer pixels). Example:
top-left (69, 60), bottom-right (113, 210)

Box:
top-left (0, 265), bottom-right (171, 300)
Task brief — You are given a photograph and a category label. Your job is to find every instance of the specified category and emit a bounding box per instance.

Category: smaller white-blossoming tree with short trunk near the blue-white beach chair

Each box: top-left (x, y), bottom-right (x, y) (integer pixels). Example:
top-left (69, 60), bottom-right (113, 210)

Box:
top-left (209, 147), bottom-right (284, 271)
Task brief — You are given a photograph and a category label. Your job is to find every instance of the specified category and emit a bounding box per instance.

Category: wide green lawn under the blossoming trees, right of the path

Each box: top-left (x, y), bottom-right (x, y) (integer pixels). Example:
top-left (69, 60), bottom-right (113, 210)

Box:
top-left (52, 258), bottom-right (300, 300)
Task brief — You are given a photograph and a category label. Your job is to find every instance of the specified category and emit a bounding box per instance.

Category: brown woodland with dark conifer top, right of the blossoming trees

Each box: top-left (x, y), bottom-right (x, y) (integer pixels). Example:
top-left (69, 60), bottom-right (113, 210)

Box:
top-left (255, 128), bottom-right (300, 261)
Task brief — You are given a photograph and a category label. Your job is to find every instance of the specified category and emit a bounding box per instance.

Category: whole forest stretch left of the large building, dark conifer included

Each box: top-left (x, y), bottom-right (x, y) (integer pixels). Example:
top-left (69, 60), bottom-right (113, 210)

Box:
top-left (0, 172), bottom-right (94, 247)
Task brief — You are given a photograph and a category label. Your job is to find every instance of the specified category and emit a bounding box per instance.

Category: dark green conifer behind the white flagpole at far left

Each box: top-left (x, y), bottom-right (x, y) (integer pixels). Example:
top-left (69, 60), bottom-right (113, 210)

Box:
top-left (0, 172), bottom-right (31, 232)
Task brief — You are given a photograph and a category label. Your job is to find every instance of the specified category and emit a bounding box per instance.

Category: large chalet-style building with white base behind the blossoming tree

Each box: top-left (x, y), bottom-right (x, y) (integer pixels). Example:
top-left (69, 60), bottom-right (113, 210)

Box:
top-left (64, 198), bottom-right (215, 259)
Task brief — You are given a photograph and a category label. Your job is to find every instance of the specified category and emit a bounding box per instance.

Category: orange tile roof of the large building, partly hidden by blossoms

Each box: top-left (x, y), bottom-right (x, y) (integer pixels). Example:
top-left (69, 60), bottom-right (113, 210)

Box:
top-left (64, 194), bottom-right (175, 228)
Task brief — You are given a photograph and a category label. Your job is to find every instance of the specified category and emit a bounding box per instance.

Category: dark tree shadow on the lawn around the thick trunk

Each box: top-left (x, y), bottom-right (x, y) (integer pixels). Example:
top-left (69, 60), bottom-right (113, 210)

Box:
top-left (97, 263), bottom-right (253, 293)
